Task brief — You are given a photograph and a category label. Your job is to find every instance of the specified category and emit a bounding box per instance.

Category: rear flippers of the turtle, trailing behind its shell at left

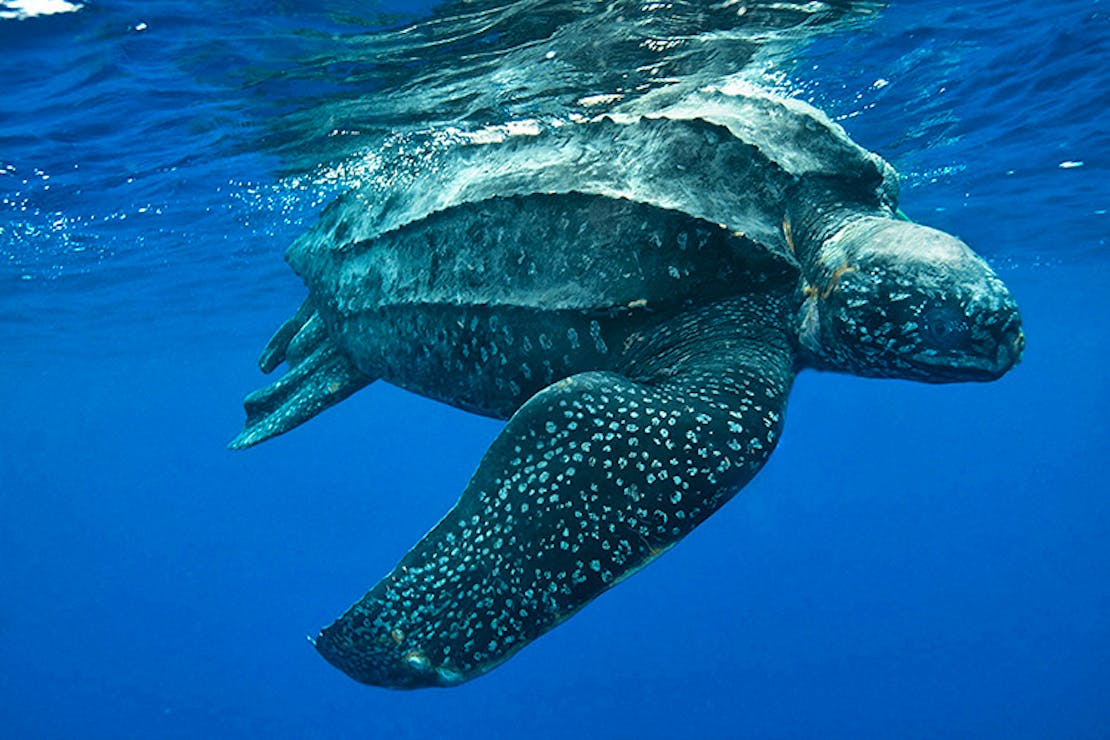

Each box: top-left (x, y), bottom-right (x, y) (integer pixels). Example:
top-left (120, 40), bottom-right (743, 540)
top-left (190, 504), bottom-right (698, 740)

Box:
top-left (228, 301), bottom-right (374, 449)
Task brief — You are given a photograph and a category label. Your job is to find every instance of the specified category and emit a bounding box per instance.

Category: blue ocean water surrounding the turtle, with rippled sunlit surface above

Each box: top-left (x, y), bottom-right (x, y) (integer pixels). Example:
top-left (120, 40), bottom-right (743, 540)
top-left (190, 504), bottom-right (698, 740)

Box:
top-left (0, 0), bottom-right (1110, 738)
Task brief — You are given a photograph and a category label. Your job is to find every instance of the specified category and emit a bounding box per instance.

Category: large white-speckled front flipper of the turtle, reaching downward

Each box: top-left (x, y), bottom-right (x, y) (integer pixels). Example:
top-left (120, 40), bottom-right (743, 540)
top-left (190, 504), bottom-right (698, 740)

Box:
top-left (314, 299), bottom-right (794, 689)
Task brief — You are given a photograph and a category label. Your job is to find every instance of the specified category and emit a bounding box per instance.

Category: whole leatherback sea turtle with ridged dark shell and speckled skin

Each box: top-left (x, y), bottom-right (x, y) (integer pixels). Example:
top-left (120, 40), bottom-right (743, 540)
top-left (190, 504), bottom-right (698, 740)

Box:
top-left (232, 89), bottom-right (1023, 688)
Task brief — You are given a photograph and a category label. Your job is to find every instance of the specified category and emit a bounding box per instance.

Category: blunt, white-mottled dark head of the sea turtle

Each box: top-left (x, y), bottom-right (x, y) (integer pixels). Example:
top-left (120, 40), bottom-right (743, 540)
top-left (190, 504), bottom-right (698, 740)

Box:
top-left (798, 216), bottom-right (1025, 383)
